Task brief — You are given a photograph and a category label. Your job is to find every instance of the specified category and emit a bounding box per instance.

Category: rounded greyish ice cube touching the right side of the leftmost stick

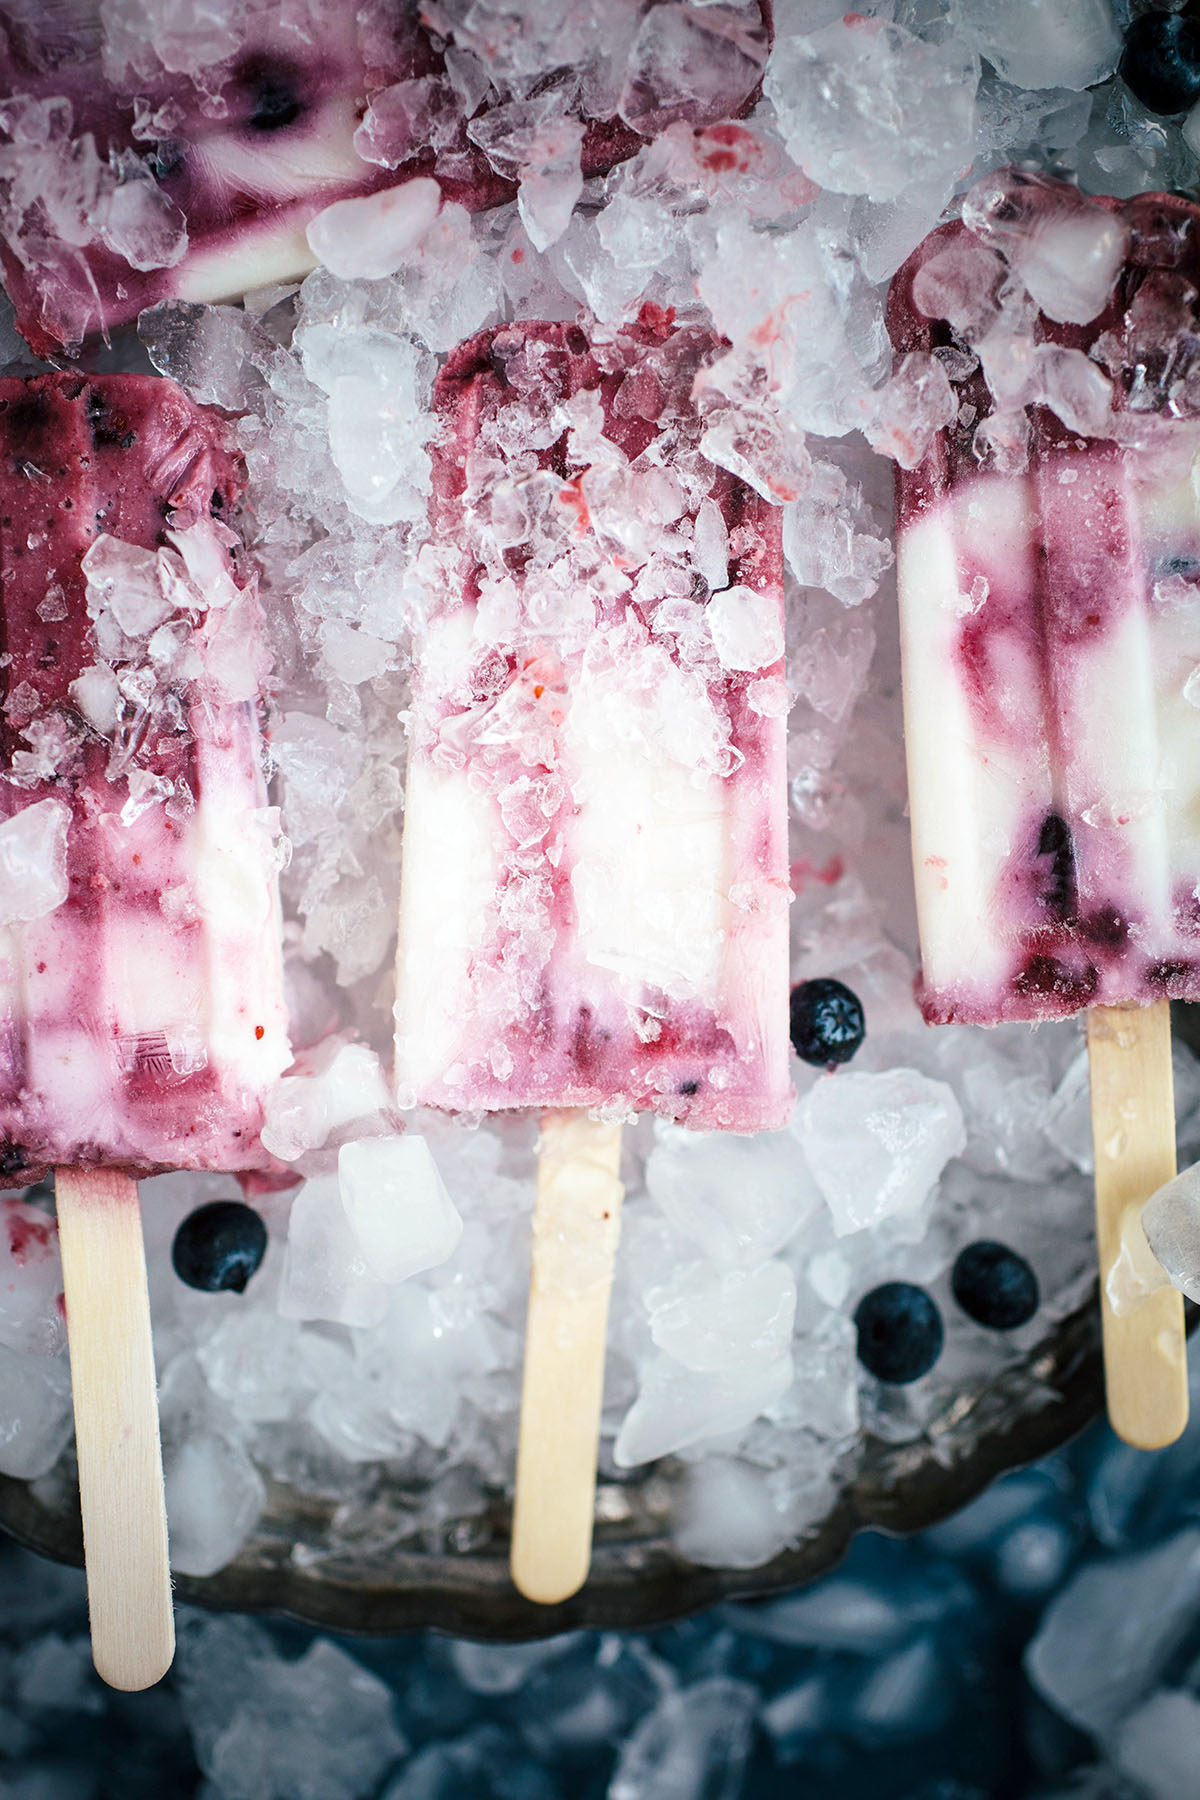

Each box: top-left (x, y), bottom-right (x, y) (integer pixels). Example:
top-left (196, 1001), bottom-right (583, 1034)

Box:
top-left (162, 1433), bottom-right (266, 1575)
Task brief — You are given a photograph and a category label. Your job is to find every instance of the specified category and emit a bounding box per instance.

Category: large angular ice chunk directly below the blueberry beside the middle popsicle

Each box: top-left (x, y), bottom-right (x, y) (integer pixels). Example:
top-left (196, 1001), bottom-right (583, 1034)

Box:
top-left (797, 1069), bottom-right (966, 1237)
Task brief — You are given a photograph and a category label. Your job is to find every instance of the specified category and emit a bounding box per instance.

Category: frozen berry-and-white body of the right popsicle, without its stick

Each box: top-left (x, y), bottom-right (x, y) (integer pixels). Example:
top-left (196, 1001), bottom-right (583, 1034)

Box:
top-left (889, 176), bottom-right (1200, 1024)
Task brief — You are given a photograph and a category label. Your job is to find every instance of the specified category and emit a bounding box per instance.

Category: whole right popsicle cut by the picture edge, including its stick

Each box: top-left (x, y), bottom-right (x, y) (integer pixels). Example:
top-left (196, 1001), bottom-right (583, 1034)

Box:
top-left (891, 171), bottom-right (1200, 1447)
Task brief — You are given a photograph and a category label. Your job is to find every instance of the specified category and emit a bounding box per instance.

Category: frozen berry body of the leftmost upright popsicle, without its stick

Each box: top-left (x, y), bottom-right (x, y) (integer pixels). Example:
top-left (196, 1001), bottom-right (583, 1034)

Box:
top-left (0, 374), bottom-right (290, 1181)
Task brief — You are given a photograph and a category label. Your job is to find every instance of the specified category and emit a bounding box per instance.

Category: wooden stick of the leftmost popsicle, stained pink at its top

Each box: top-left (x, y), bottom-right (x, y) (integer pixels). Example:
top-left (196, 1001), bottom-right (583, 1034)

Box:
top-left (54, 1168), bottom-right (175, 1692)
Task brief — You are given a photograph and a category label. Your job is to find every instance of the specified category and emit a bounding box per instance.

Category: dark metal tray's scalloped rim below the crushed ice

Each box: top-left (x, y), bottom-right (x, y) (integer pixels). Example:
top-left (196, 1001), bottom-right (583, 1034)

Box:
top-left (0, 1300), bottom-right (1103, 1642)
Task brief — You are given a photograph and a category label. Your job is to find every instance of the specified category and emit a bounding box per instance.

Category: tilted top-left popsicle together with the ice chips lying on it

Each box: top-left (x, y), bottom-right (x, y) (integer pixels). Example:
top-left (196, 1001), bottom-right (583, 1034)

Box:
top-left (0, 0), bottom-right (770, 355)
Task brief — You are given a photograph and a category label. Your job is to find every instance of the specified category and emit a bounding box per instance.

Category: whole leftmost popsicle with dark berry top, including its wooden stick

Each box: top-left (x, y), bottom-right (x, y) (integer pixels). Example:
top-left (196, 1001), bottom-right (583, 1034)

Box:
top-left (0, 374), bottom-right (290, 1687)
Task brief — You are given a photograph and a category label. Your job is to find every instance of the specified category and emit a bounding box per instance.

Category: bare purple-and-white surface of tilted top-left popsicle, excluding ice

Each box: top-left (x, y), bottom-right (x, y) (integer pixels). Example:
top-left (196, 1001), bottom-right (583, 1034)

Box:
top-left (0, 0), bottom-right (772, 356)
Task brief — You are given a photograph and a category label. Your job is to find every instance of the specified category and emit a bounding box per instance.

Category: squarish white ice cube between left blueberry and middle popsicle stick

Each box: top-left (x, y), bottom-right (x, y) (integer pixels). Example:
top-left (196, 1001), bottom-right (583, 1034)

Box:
top-left (338, 1134), bottom-right (462, 1285)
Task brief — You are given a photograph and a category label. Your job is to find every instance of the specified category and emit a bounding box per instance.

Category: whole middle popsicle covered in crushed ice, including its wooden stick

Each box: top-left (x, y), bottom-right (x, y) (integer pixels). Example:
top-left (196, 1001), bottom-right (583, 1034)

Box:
top-left (396, 308), bottom-right (792, 1600)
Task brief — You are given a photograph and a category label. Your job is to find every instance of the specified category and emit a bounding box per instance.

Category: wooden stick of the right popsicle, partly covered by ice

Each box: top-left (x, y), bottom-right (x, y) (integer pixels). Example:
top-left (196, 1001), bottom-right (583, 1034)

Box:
top-left (1087, 1001), bottom-right (1187, 1451)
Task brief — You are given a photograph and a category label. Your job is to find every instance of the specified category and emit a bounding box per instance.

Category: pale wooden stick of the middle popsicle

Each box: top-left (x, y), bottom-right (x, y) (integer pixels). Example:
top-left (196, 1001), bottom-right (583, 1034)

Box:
top-left (511, 1112), bottom-right (624, 1606)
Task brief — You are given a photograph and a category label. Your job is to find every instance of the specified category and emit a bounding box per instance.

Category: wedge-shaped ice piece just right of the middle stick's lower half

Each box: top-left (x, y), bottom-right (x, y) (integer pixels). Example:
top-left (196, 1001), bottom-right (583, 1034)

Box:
top-left (612, 1354), bottom-right (792, 1469)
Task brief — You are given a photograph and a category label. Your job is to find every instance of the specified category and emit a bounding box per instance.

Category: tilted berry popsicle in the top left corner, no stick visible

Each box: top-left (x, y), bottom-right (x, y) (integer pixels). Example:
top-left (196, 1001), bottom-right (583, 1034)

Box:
top-left (0, 0), bottom-right (770, 355)
